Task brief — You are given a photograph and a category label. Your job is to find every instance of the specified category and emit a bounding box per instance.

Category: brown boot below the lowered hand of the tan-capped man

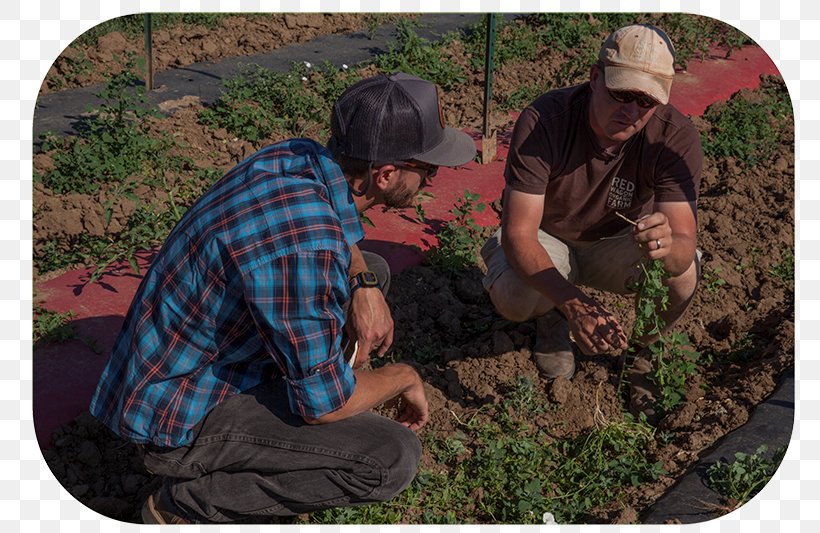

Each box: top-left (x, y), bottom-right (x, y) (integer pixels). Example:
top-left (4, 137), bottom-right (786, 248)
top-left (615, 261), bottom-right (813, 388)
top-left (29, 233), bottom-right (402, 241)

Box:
top-left (532, 310), bottom-right (575, 379)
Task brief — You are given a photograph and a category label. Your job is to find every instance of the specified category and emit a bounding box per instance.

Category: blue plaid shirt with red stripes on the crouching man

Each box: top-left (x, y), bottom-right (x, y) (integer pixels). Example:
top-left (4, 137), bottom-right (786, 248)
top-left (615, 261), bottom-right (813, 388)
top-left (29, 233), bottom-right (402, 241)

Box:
top-left (91, 139), bottom-right (364, 447)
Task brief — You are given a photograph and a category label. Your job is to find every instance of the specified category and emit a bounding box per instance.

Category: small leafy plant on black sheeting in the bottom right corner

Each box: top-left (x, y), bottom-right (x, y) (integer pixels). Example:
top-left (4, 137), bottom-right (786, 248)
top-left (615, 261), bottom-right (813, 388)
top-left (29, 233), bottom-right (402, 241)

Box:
top-left (706, 444), bottom-right (786, 509)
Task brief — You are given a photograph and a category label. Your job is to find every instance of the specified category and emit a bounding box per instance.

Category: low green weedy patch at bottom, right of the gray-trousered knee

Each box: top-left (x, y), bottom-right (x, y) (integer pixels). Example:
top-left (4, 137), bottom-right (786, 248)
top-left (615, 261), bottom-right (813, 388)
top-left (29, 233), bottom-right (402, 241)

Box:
top-left (309, 381), bottom-right (664, 524)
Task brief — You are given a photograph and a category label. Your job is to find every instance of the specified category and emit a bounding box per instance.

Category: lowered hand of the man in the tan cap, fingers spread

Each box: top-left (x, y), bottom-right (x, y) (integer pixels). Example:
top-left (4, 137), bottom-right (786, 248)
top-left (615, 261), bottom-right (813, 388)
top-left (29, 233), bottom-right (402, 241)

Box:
top-left (559, 294), bottom-right (627, 355)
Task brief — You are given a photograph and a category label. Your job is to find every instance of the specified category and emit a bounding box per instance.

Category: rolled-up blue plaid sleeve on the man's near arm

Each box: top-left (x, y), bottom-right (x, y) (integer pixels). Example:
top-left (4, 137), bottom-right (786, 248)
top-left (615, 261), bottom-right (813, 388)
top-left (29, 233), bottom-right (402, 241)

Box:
top-left (246, 249), bottom-right (356, 418)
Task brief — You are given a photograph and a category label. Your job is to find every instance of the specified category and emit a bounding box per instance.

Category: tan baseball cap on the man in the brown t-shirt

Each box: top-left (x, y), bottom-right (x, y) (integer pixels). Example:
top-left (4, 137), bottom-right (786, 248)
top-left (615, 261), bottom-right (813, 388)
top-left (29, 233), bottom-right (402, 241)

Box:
top-left (598, 24), bottom-right (675, 104)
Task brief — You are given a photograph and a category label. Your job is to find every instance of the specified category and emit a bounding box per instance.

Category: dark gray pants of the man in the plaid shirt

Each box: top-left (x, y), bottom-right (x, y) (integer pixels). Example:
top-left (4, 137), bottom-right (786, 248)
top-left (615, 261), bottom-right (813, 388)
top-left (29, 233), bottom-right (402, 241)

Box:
top-left (144, 253), bottom-right (421, 522)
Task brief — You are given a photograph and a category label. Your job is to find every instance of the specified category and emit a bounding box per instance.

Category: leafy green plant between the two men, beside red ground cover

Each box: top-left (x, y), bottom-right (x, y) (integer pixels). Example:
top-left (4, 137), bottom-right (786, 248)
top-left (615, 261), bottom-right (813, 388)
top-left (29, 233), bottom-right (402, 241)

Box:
top-left (427, 190), bottom-right (487, 274)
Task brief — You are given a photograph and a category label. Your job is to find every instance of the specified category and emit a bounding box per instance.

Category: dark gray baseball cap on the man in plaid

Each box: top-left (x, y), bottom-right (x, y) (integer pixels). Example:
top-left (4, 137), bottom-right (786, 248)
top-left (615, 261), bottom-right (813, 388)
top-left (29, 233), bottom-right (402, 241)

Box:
top-left (329, 72), bottom-right (476, 167)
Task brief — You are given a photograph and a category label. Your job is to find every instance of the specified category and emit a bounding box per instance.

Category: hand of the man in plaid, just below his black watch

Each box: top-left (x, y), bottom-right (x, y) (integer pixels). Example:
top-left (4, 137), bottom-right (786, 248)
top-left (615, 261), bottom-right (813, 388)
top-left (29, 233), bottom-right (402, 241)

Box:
top-left (345, 287), bottom-right (393, 368)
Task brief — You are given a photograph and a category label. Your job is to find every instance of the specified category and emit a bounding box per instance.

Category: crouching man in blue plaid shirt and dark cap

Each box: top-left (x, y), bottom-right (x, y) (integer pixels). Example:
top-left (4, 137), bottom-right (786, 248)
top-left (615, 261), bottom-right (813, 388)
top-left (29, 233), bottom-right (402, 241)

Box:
top-left (91, 74), bottom-right (475, 523)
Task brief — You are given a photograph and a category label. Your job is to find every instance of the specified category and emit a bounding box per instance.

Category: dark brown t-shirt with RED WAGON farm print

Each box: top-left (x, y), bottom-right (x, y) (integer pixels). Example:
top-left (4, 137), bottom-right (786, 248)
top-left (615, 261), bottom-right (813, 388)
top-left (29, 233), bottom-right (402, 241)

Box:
top-left (504, 83), bottom-right (702, 241)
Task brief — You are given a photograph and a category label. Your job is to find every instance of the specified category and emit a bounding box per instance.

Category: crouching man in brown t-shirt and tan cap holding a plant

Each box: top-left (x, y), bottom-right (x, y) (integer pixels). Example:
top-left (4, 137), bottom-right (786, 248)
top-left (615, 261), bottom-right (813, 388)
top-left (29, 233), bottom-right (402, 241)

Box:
top-left (482, 25), bottom-right (702, 419)
